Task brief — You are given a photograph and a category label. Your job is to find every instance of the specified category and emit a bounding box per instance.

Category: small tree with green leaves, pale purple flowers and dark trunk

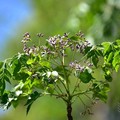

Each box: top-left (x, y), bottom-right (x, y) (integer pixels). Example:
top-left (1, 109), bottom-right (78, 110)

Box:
top-left (0, 32), bottom-right (120, 120)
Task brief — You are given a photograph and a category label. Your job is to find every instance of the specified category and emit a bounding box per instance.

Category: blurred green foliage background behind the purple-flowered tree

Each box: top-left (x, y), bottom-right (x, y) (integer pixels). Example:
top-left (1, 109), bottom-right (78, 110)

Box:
top-left (0, 0), bottom-right (120, 120)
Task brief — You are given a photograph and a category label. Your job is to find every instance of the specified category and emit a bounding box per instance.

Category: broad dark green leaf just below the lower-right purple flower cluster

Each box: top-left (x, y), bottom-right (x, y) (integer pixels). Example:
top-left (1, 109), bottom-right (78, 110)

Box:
top-left (78, 69), bottom-right (94, 83)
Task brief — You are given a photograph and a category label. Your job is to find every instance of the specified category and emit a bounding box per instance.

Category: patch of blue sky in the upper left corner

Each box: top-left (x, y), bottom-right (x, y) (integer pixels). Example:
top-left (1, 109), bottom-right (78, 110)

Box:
top-left (0, 0), bottom-right (31, 58)
